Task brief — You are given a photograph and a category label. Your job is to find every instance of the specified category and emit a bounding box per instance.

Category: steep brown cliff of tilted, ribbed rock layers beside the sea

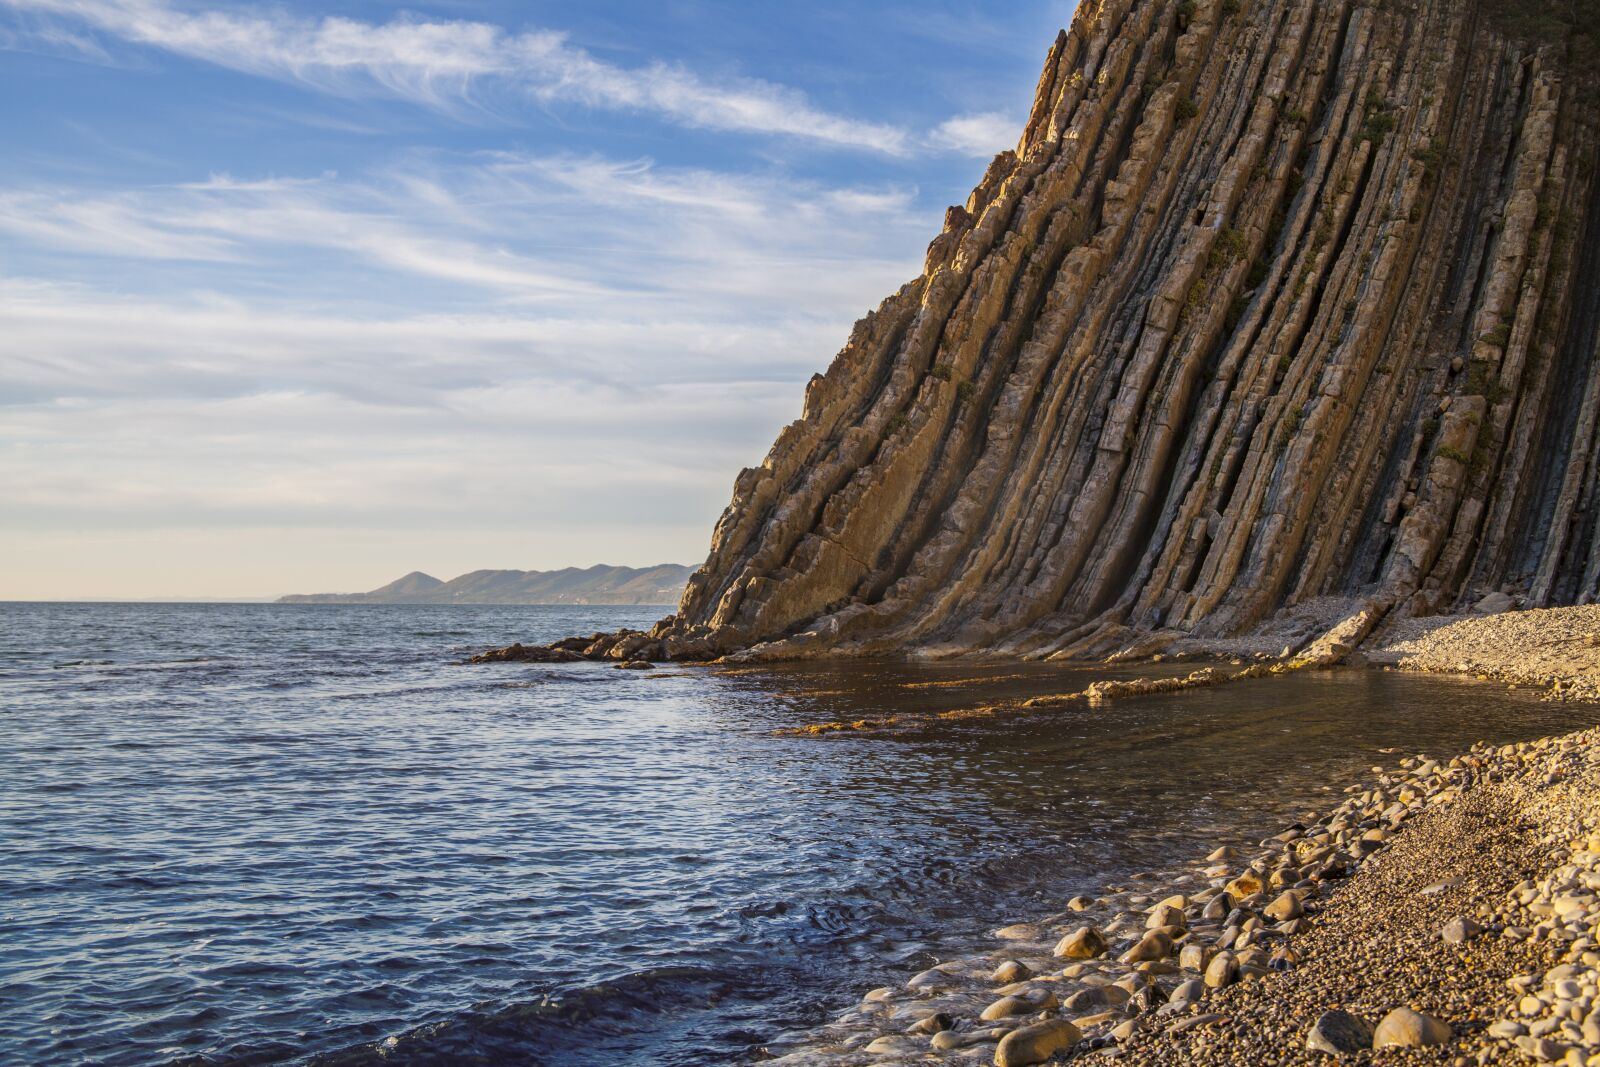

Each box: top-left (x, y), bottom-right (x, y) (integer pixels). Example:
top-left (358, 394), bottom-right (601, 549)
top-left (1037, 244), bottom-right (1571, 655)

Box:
top-left (633, 0), bottom-right (1600, 657)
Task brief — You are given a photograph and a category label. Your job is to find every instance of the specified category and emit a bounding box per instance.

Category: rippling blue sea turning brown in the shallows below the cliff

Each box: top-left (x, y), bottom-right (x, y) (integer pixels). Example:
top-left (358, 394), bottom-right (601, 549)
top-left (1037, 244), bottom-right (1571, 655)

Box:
top-left (0, 605), bottom-right (1600, 1064)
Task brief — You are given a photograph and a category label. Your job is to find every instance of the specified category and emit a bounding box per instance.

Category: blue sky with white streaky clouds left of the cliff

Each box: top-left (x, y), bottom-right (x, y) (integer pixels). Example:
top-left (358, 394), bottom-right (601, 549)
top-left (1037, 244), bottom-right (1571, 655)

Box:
top-left (0, 0), bottom-right (1072, 600)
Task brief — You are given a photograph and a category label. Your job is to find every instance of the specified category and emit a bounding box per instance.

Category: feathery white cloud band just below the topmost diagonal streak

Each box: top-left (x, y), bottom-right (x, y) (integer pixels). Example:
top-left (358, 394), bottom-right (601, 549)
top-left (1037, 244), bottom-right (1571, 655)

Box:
top-left (0, 152), bottom-right (931, 315)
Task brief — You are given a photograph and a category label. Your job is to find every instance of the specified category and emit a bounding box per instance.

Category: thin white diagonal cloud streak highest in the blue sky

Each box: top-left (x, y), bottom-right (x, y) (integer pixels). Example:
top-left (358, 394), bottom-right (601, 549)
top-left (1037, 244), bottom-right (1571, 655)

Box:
top-left (0, 0), bottom-right (912, 155)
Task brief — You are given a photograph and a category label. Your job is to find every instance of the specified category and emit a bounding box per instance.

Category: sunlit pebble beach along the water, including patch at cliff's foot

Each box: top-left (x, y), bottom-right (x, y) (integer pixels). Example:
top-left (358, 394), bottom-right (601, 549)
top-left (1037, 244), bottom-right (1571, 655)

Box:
top-left (758, 608), bottom-right (1600, 1067)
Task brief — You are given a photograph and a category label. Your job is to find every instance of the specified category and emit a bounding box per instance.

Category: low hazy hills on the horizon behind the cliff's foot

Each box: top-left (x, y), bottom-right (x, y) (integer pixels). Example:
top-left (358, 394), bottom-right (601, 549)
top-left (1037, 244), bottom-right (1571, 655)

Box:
top-left (278, 563), bottom-right (694, 605)
